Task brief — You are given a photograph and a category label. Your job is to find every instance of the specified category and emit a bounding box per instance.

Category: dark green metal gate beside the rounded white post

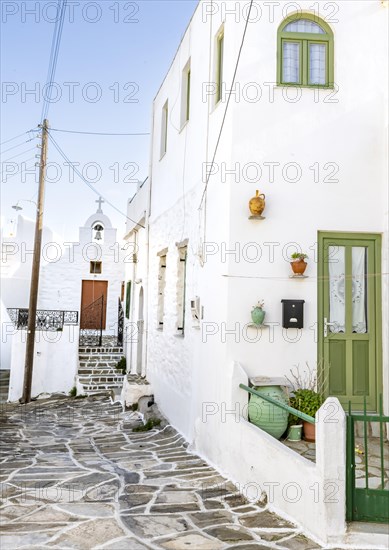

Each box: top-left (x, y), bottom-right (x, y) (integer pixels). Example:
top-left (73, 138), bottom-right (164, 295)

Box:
top-left (346, 395), bottom-right (389, 523)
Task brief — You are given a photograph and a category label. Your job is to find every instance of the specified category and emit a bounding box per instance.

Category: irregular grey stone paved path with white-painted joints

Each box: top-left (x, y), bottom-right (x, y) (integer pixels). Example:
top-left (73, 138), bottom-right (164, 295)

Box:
top-left (0, 396), bottom-right (318, 550)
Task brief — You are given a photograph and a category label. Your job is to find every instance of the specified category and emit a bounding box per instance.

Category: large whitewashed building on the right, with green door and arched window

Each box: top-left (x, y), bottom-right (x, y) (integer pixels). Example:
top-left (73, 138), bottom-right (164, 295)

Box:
top-left (126, 0), bottom-right (389, 547)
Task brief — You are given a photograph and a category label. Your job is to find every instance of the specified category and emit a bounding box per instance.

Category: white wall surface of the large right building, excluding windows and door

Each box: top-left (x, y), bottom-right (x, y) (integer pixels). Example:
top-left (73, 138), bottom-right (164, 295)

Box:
top-left (128, 1), bottom-right (389, 541)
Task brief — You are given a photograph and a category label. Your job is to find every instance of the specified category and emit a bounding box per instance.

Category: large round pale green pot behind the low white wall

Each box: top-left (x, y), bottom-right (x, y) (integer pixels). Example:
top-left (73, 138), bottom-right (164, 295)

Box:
top-left (248, 386), bottom-right (289, 439)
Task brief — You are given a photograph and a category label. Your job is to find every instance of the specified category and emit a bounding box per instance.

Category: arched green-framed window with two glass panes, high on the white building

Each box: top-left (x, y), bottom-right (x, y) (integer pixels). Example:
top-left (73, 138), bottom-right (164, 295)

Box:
top-left (277, 13), bottom-right (334, 88)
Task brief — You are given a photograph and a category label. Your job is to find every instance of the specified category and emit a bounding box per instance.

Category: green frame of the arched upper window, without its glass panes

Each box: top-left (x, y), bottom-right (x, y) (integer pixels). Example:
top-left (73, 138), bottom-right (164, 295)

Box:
top-left (277, 13), bottom-right (334, 88)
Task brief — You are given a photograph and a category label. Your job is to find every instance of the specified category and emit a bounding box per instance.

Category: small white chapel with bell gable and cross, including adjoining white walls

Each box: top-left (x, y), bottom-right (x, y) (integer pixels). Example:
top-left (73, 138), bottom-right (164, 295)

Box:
top-left (2, 200), bottom-right (124, 401)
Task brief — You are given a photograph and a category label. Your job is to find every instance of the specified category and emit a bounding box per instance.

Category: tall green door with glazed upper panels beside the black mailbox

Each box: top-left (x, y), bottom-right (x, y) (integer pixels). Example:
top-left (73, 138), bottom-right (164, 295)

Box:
top-left (318, 232), bottom-right (382, 412)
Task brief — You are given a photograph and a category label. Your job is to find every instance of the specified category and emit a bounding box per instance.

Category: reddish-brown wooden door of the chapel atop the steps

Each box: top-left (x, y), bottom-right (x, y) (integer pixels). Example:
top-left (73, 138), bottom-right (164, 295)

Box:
top-left (80, 281), bottom-right (108, 330)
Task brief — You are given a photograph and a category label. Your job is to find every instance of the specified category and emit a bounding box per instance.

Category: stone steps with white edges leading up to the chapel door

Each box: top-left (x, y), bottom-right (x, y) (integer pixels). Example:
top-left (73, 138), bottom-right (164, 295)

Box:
top-left (76, 346), bottom-right (124, 395)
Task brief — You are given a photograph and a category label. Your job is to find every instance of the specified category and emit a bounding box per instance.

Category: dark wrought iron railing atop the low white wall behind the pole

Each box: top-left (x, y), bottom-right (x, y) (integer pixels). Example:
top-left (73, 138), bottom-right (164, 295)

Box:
top-left (7, 308), bottom-right (78, 331)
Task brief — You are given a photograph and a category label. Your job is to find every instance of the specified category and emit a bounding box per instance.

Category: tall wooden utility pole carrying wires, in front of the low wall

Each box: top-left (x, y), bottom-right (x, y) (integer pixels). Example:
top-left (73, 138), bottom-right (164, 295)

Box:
top-left (20, 119), bottom-right (49, 403)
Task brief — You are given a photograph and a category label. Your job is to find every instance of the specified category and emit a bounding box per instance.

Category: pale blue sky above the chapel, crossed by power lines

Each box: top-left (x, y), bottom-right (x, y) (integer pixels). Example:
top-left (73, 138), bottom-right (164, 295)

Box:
top-left (1, 0), bottom-right (197, 240)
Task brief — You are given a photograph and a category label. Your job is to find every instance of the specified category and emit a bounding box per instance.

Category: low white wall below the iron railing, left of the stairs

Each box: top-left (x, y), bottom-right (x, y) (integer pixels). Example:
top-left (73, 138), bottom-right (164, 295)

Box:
top-left (8, 326), bottom-right (79, 401)
